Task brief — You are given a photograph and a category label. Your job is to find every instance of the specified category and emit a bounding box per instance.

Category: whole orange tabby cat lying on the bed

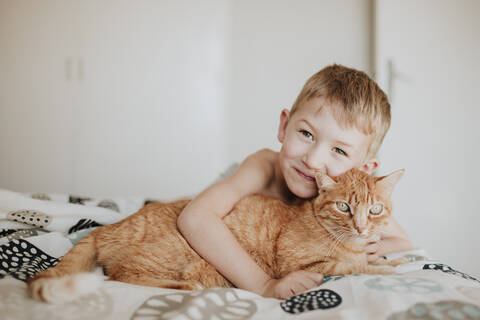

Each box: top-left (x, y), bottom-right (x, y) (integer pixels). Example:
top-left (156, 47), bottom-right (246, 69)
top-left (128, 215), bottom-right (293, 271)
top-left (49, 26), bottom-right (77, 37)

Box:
top-left (28, 169), bottom-right (403, 302)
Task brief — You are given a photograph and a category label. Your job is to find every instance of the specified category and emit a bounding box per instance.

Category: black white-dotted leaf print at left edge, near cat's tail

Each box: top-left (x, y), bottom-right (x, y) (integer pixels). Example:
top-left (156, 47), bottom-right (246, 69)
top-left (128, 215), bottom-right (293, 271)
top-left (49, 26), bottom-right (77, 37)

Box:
top-left (0, 239), bottom-right (60, 281)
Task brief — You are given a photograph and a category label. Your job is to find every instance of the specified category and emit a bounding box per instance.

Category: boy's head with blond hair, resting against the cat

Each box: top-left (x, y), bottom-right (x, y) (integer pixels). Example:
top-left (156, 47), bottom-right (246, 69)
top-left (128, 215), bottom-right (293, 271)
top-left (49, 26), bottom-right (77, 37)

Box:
top-left (278, 65), bottom-right (390, 198)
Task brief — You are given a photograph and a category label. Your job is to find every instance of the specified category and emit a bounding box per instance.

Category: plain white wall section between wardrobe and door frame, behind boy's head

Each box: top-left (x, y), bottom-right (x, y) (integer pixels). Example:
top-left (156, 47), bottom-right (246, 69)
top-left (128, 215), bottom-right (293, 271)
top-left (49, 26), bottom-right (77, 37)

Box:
top-left (228, 0), bottom-right (370, 160)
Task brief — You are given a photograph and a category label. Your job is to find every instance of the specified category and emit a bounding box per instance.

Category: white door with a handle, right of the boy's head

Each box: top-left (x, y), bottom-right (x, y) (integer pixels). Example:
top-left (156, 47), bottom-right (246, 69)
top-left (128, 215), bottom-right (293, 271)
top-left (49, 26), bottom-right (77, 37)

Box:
top-left (377, 0), bottom-right (480, 277)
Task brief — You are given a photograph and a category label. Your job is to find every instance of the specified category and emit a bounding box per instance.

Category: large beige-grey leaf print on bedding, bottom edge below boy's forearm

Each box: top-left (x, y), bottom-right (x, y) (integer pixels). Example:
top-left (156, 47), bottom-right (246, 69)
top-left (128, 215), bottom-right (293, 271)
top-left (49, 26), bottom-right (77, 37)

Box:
top-left (131, 288), bottom-right (257, 320)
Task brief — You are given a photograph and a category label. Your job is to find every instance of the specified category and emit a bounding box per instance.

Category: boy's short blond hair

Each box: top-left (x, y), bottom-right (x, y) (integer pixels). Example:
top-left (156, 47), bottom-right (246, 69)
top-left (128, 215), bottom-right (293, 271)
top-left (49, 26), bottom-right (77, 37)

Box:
top-left (290, 64), bottom-right (391, 159)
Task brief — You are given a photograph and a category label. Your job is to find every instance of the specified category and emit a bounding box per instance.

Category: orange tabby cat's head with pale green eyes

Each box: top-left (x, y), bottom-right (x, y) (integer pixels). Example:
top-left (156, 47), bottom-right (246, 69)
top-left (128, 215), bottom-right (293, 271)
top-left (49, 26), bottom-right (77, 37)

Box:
top-left (313, 169), bottom-right (405, 237)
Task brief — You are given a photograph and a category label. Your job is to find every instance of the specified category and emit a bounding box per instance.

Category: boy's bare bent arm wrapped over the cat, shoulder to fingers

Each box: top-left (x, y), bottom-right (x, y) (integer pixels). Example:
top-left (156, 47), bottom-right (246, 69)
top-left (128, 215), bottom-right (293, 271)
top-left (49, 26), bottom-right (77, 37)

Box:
top-left (177, 151), bottom-right (321, 298)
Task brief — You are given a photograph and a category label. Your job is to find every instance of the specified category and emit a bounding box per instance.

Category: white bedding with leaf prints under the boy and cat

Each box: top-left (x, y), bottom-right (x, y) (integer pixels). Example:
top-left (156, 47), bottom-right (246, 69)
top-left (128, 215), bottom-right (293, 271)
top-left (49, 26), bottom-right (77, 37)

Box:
top-left (0, 189), bottom-right (480, 320)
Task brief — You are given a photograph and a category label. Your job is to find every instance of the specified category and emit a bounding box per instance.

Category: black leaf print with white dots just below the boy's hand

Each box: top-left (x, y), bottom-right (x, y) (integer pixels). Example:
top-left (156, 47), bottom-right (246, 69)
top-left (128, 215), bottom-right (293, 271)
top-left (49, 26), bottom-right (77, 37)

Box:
top-left (280, 289), bottom-right (342, 314)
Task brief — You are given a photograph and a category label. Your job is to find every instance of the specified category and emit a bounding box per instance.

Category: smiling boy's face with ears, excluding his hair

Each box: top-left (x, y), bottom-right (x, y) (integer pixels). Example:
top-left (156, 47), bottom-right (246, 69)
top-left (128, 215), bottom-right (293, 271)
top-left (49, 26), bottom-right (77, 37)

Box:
top-left (278, 98), bottom-right (378, 198)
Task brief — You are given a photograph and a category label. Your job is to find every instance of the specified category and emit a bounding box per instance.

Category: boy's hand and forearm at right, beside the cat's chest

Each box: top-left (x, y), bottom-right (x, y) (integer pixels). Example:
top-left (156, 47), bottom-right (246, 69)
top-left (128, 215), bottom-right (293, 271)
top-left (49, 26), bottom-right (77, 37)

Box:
top-left (366, 217), bottom-right (413, 261)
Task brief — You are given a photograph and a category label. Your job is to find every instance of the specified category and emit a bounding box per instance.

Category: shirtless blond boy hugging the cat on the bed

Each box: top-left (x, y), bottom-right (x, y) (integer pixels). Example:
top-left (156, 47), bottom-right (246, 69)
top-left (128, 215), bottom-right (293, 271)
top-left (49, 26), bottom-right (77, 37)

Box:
top-left (177, 65), bottom-right (411, 299)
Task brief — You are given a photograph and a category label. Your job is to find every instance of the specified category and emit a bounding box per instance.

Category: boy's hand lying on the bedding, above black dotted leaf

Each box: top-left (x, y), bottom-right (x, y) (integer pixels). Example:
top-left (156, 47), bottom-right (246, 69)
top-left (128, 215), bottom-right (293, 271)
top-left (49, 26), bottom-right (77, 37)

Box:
top-left (262, 270), bottom-right (323, 299)
